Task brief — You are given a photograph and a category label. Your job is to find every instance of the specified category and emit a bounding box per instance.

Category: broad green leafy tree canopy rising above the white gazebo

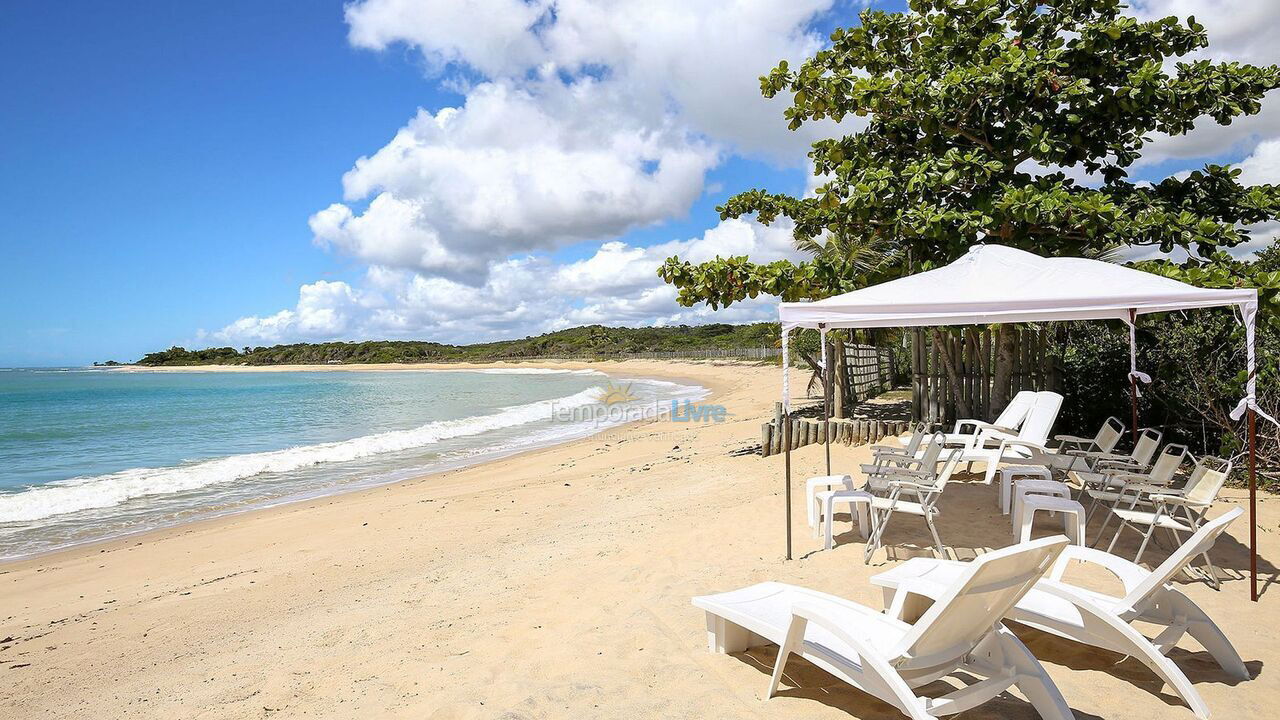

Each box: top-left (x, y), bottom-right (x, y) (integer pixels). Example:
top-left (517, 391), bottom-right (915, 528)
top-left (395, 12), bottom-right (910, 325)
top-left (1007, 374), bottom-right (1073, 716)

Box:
top-left (658, 0), bottom-right (1280, 307)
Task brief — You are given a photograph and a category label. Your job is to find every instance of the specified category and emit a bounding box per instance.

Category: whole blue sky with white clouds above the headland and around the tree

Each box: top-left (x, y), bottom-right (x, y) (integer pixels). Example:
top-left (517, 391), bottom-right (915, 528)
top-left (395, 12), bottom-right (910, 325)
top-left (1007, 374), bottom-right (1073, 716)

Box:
top-left (0, 0), bottom-right (1280, 366)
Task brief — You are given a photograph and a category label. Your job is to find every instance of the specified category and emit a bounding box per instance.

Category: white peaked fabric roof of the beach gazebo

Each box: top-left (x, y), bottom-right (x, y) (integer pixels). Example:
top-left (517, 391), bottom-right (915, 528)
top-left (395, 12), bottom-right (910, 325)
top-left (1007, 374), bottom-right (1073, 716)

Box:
top-left (778, 245), bottom-right (1258, 328)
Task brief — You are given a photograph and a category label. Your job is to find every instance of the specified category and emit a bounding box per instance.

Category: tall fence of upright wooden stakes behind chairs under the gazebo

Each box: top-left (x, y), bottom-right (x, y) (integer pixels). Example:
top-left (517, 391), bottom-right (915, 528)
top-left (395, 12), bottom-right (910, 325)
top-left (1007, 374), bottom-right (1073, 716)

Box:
top-left (911, 325), bottom-right (1057, 423)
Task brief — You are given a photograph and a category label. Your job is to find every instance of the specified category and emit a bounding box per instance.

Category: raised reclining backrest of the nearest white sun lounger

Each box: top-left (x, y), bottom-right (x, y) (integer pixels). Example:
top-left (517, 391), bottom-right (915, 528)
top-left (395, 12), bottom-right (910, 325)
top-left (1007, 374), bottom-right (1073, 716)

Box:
top-left (890, 536), bottom-right (1068, 670)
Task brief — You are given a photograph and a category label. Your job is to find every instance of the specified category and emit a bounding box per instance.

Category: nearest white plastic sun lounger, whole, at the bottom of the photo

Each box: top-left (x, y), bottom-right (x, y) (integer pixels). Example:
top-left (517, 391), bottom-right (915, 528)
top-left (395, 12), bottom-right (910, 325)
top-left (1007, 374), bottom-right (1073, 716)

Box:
top-left (694, 537), bottom-right (1073, 720)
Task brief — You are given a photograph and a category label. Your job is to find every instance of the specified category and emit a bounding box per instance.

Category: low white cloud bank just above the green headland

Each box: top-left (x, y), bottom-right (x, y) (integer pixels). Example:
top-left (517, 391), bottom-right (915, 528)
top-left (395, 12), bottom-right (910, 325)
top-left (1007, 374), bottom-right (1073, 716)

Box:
top-left (202, 220), bottom-right (800, 346)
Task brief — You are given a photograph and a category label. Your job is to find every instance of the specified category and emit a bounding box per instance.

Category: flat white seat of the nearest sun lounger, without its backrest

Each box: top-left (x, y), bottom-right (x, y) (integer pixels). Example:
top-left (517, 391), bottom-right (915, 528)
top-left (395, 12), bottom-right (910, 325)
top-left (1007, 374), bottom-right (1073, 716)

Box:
top-left (694, 582), bottom-right (911, 669)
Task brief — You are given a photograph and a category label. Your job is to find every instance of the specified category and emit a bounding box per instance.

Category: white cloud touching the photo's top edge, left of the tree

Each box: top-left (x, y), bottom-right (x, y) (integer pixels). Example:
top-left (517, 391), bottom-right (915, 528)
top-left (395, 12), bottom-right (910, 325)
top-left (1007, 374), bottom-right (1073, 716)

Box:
top-left (347, 0), bottom-right (836, 156)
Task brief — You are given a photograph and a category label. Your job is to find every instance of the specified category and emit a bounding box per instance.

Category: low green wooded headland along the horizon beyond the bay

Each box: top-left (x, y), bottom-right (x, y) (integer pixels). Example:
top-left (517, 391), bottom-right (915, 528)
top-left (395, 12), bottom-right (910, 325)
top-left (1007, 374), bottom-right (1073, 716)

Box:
top-left (129, 323), bottom-right (778, 366)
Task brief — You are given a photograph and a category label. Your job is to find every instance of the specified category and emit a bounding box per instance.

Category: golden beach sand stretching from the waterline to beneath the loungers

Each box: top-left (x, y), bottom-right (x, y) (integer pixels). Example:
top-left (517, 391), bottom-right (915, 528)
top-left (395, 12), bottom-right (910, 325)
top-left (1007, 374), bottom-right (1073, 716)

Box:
top-left (0, 361), bottom-right (1280, 719)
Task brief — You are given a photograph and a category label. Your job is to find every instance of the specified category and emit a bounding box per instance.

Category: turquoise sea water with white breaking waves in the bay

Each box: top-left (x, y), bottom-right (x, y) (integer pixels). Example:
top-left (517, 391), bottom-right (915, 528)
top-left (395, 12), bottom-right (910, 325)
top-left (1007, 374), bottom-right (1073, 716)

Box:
top-left (0, 369), bottom-right (705, 557)
